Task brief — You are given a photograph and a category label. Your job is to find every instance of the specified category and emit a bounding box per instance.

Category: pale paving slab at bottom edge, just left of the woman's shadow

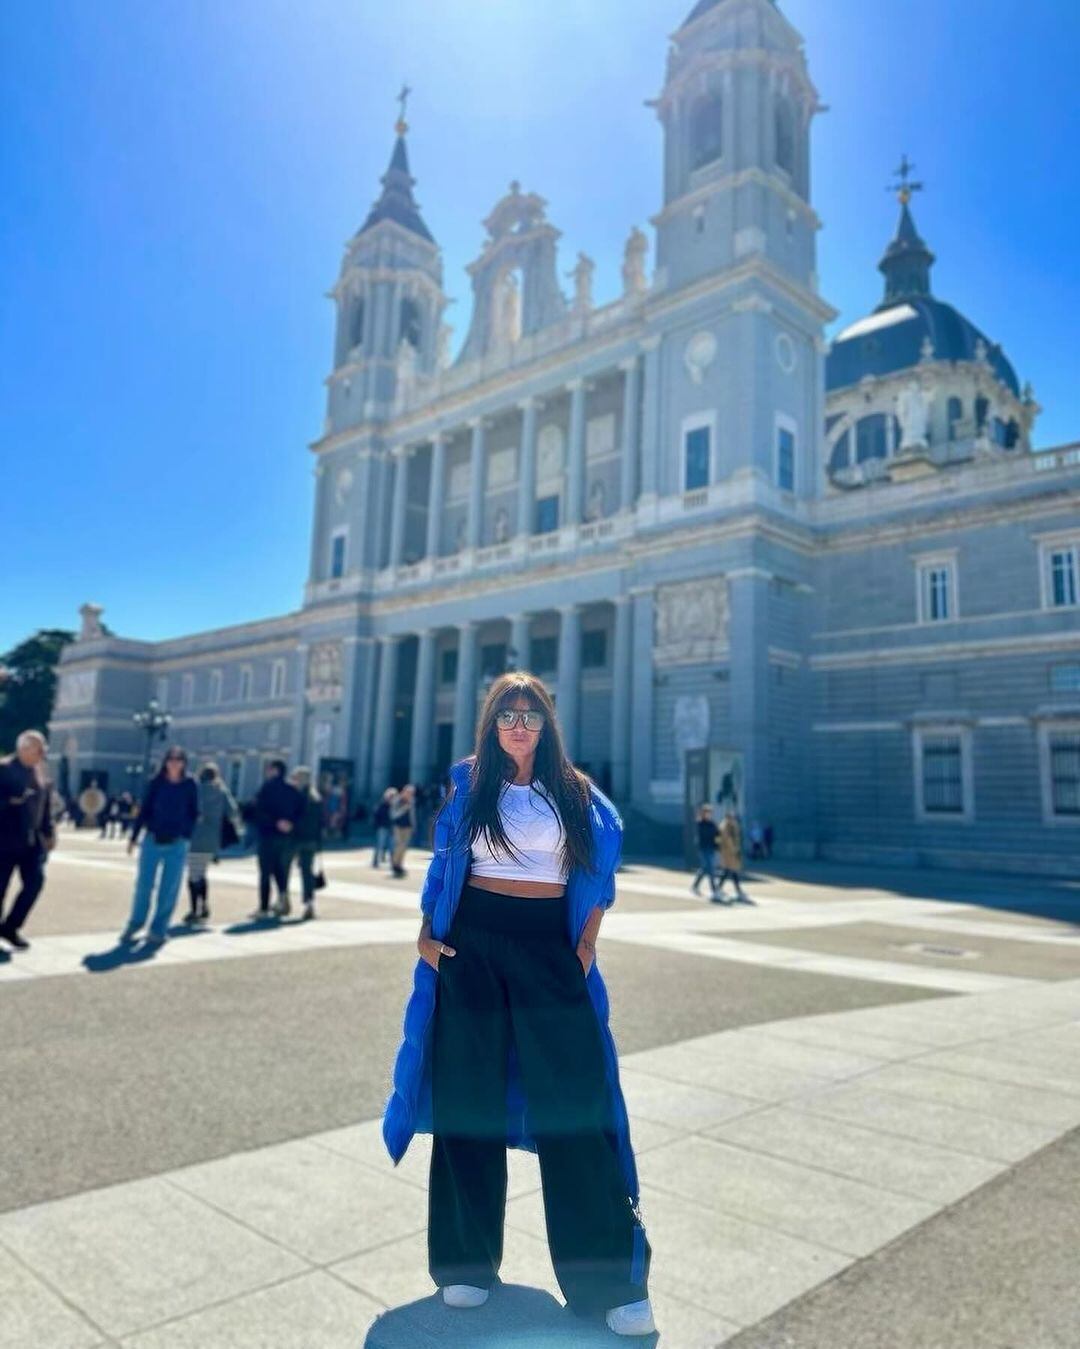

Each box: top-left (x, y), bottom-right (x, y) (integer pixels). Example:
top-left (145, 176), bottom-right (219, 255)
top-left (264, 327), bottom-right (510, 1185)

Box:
top-left (121, 1269), bottom-right (383, 1349)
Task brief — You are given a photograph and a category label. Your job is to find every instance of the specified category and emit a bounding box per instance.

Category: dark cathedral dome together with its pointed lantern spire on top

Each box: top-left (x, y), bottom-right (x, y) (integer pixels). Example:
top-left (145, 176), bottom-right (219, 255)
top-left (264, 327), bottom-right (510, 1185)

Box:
top-left (825, 199), bottom-right (1019, 395)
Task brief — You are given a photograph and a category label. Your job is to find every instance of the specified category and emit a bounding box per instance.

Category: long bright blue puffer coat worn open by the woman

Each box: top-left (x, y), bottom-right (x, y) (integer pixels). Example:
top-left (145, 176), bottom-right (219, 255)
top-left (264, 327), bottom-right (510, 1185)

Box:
top-left (383, 759), bottom-right (638, 1209)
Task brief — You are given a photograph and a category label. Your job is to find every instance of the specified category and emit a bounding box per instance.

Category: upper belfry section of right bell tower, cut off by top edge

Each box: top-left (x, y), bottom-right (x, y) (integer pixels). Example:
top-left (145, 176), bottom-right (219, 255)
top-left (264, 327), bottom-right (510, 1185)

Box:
top-left (654, 0), bottom-right (820, 295)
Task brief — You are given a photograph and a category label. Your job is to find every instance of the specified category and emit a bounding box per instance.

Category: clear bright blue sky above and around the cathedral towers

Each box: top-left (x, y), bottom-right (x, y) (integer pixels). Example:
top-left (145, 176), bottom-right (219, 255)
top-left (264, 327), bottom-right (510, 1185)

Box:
top-left (0, 0), bottom-right (1080, 650)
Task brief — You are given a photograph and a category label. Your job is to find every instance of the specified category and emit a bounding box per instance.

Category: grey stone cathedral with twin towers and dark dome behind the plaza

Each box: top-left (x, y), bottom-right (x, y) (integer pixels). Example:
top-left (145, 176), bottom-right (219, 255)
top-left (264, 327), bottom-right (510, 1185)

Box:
top-left (50, 0), bottom-right (1080, 873)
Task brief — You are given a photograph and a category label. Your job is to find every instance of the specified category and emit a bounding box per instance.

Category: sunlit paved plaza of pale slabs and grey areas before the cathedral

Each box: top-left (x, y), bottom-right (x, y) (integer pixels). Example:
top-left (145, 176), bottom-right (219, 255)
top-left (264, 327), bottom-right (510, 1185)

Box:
top-left (0, 830), bottom-right (1080, 1349)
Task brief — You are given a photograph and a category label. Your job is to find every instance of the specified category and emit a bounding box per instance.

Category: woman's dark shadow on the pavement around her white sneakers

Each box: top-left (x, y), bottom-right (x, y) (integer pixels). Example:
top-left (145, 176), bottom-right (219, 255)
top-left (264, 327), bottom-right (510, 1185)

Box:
top-left (364, 1283), bottom-right (659, 1349)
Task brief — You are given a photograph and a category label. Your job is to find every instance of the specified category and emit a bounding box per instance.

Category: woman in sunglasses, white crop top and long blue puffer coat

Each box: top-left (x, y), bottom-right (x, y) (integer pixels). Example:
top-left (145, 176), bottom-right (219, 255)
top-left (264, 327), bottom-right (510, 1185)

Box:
top-left (383, 672), bottom-right (654, 1336)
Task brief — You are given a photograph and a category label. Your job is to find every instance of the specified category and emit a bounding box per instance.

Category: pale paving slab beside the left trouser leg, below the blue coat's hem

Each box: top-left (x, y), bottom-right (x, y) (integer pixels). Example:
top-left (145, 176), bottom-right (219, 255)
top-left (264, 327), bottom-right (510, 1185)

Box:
top-left (169, 1141), bottom-right (427, 1264)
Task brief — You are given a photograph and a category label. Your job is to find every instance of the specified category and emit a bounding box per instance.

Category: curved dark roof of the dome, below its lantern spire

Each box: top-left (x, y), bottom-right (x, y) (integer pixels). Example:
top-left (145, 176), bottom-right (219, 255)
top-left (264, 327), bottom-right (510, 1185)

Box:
top-left (825, 295), bottom-right (1019, 395)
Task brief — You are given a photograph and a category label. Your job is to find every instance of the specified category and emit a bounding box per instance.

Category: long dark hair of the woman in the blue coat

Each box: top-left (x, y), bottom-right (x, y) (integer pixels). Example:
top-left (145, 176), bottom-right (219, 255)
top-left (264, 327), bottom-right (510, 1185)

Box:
top-left (450, 670), bottom-right (595, 871)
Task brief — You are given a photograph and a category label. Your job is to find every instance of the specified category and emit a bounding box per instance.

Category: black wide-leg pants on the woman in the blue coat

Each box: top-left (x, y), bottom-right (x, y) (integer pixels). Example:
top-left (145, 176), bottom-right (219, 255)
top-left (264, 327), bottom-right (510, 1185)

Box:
top-left (427, 885), bottom-right (651, 1314)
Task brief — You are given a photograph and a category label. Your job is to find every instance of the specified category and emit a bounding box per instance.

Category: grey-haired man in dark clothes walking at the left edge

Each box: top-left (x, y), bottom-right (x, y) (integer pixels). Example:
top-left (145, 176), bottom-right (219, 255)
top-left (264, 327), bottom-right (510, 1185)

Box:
top-left (0, 731), bottom-right (57, 951)
